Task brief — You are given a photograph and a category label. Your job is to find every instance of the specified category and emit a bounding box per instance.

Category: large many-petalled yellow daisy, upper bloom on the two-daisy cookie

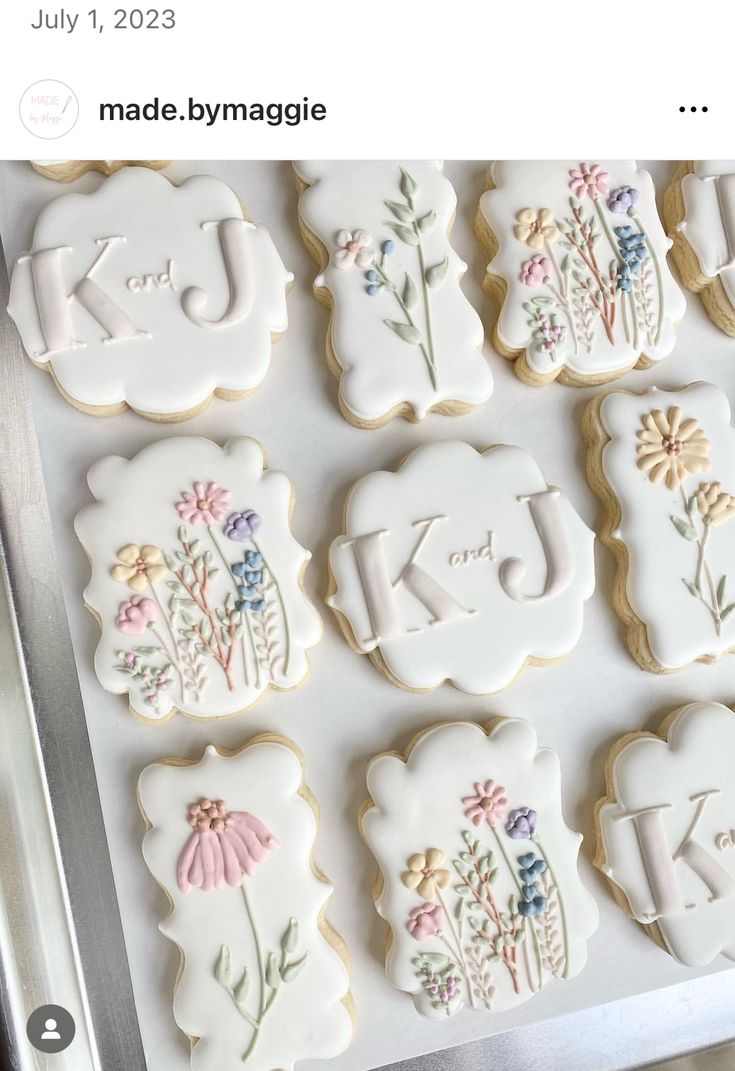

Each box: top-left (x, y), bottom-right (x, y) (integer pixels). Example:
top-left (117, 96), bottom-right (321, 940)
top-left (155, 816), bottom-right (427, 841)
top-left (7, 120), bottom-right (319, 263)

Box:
top-left (638, 405), bottom-right (711, 491)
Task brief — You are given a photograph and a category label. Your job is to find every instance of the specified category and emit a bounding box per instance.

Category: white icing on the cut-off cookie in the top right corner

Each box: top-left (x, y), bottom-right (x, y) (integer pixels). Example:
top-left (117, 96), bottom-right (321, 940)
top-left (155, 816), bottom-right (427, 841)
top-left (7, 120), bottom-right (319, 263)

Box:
top-left (677, 160), bottom-right (735, 302)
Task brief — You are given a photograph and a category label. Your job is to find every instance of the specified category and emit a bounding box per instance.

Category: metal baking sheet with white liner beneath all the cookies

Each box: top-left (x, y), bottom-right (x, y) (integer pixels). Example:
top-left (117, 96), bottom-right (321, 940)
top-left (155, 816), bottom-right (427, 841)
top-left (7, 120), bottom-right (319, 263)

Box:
top-left (0, 162), bottom-right (735, 1071)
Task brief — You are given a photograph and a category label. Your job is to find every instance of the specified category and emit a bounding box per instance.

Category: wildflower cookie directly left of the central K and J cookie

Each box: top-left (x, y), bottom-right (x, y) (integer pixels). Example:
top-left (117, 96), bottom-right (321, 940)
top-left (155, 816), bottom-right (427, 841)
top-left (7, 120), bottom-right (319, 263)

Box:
top-left (76, 438), bottom-right (320, 721)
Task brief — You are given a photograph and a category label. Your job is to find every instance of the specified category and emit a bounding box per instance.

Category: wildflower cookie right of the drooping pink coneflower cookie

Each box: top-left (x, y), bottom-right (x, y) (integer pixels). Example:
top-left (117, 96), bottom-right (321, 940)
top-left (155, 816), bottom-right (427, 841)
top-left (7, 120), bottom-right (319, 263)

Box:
top-left (361, 719), bottom-right (597, 1017)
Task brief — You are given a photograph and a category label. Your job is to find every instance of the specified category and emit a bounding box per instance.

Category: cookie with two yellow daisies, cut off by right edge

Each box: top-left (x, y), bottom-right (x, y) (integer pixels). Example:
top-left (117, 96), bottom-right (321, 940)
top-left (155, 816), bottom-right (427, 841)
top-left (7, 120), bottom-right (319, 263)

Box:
top-left (584, 383), bottom-right (735, 673)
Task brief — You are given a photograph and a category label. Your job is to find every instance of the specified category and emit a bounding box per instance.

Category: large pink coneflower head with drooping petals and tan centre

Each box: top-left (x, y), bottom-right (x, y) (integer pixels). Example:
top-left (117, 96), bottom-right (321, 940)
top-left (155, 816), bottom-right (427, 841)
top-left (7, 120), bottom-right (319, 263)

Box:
top-left (177, 798), bottom-right (280, 892)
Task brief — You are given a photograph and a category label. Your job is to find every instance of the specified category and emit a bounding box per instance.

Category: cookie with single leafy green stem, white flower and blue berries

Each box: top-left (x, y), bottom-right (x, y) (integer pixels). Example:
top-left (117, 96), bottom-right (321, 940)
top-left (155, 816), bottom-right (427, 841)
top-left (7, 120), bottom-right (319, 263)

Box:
top-left (295, 161), bottom-right (493, 427)
